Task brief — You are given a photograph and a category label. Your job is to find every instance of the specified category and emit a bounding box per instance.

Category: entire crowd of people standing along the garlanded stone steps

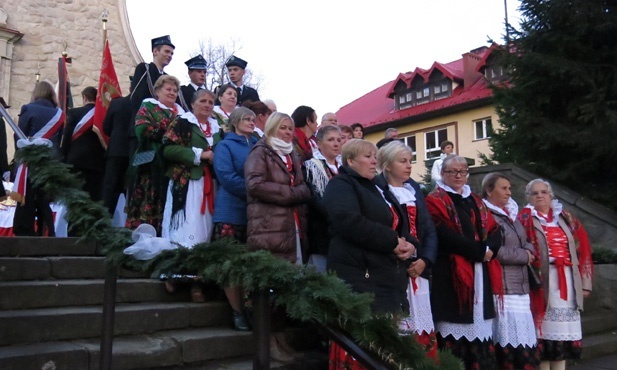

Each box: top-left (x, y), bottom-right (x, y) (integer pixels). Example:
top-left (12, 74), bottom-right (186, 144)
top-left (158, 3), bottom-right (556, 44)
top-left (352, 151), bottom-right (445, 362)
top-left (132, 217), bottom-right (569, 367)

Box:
top-left (9, 36), bottom-right (593, 370)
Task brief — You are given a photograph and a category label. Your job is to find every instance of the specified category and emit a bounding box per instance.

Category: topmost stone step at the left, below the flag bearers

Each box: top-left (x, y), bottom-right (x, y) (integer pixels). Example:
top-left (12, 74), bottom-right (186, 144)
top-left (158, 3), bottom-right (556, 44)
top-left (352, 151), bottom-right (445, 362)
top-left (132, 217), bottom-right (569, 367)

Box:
top-left (0, 236), bottom-right (101, 257)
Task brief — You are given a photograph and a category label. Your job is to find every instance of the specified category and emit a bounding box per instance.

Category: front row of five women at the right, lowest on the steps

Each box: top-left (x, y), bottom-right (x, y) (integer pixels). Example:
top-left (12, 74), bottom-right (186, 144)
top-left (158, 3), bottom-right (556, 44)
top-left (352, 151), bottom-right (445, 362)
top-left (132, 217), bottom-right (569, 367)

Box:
top-left (324, 140), bottom-right (593, 370)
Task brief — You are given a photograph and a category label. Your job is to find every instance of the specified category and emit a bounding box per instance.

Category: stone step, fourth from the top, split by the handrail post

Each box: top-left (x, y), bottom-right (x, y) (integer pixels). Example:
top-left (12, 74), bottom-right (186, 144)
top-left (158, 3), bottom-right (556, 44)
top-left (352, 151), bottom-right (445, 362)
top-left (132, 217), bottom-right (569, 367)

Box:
top-left (0, 301), bottom-right (232, 346)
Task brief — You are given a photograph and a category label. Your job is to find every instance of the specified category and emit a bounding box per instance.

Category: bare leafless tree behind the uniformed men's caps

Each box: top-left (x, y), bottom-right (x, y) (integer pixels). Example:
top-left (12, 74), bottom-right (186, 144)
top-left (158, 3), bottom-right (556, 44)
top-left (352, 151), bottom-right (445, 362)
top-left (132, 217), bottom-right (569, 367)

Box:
top-left (191, 39), bottom-right (262, 91)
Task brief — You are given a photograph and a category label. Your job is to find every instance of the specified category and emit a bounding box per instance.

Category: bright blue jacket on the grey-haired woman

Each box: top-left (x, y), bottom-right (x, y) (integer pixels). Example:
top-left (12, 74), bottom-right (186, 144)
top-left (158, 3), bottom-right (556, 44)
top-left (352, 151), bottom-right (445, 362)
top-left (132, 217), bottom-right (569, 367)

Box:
top-left (213, 132), bottom-right (257, 225)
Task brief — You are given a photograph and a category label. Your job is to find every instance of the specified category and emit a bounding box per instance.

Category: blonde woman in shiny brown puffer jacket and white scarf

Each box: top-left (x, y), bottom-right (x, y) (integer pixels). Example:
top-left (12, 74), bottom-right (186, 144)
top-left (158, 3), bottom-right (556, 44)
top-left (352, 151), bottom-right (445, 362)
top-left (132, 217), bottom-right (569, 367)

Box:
top-left (244, 112), bottom-right (311, 362)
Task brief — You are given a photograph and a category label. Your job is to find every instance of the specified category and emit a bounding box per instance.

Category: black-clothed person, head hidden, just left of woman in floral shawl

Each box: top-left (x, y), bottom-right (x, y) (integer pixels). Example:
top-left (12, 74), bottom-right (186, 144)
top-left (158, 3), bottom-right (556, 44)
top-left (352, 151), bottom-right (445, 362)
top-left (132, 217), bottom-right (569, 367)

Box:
top-left (103, 95), bottom-right (131, 216)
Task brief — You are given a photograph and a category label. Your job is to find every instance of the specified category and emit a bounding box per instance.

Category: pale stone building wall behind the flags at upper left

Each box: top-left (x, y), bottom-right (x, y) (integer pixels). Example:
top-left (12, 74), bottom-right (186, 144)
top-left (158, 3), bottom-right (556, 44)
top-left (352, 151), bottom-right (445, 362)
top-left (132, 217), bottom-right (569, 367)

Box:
top-left (0, 0), bottom-right (141, 158)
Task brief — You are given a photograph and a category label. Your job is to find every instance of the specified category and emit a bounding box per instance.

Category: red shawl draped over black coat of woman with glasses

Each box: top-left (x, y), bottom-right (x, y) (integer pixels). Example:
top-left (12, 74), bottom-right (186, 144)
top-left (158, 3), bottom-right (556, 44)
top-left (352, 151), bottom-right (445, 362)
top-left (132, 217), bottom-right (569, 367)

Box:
top-left (426, 187), bottom-right (504, 312)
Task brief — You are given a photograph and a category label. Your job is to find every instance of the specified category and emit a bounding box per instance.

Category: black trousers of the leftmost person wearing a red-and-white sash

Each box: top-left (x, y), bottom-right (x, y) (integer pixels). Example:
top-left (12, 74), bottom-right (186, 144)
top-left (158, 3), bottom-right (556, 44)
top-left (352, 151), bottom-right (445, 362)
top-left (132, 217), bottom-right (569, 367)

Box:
top-left (13, 181), bottom-right (56, 236)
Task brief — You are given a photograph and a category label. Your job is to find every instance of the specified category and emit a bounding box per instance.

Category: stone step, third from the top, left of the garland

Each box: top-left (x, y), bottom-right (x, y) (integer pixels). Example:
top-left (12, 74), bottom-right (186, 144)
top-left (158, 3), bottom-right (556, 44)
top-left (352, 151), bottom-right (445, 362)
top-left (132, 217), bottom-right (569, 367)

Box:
top-left (0, 279), bottom-right (195, 310)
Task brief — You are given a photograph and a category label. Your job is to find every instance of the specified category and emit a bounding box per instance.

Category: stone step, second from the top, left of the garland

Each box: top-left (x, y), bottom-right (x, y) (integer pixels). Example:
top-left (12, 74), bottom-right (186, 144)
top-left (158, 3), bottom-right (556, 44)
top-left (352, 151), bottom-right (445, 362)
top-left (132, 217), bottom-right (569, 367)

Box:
top-left (0, 256), bottom-right (149, 281)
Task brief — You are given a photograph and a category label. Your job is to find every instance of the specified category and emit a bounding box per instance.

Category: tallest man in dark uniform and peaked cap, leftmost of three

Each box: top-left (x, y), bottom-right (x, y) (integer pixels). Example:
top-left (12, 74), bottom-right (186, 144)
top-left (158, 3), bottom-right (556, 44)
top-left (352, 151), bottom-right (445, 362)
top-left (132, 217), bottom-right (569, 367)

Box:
top-left (129, 35), bottom-right (176, 154)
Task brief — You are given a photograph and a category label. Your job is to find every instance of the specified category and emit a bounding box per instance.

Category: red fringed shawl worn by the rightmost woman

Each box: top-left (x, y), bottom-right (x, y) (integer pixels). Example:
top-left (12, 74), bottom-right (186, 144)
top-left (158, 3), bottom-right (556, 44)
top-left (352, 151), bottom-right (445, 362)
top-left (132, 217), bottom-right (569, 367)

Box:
top-left (518, 208), bottom-right (593, 328)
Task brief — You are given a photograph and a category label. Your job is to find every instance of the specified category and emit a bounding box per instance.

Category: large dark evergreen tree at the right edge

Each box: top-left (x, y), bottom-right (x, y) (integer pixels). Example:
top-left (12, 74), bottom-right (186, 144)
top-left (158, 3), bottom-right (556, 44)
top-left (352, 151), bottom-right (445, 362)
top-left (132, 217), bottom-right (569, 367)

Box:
top-left (490, 0), bottom-right (617, 209)
